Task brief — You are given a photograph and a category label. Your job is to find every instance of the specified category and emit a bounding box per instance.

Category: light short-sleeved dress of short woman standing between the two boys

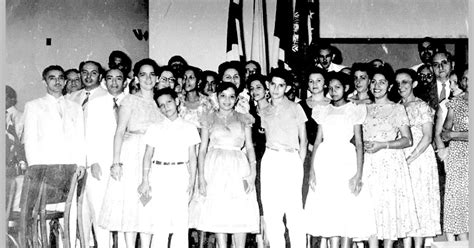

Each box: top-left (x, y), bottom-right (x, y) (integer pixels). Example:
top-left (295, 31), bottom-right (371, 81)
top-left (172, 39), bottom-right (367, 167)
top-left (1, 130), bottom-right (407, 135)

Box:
top-left (199, 111), bottom-right (260, 233)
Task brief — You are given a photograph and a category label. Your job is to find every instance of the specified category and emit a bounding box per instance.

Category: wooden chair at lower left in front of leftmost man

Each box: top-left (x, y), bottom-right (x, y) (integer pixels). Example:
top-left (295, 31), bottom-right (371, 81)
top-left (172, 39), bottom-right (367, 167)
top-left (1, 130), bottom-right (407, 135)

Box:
top-left (19, 164), bottom-right (85, 248)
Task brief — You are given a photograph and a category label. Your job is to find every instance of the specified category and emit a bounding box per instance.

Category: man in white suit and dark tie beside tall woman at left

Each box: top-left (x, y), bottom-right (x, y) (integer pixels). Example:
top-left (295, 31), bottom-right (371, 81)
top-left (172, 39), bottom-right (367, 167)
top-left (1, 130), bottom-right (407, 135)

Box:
top-left (83, 67), bottom-right (127, 247)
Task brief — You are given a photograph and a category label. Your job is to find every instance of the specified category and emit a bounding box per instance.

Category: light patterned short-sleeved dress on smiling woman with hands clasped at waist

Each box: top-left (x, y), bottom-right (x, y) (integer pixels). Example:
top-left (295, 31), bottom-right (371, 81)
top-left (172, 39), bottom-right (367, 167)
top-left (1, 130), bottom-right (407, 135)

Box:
top-left (361, 103), bottom-right (420, 240)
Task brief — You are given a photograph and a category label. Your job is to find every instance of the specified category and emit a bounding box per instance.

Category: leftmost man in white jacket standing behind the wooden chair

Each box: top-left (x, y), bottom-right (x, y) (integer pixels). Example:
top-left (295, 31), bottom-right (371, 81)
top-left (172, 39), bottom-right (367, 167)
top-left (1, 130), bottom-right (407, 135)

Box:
top-left (21, 65), bottom-right (86, 248)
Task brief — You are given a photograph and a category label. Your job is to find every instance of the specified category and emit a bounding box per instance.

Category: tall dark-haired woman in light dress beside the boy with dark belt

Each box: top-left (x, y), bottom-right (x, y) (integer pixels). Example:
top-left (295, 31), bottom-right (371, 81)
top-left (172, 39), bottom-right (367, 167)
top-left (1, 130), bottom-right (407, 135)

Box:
top-left (99, 59), bottom-right (164, 248)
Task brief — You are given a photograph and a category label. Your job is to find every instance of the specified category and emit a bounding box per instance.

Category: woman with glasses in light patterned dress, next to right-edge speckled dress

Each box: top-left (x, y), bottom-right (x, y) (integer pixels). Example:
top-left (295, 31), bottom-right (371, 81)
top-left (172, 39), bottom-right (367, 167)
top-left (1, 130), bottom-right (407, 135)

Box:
top-left (395, 68), bottom-right (441, 248)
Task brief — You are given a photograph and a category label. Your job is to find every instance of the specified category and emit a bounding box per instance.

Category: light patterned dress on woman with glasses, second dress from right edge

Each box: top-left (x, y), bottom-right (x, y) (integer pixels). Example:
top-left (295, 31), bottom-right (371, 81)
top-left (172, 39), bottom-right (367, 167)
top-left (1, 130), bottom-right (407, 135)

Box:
top-left (403, 98), bottom-right (441, 237)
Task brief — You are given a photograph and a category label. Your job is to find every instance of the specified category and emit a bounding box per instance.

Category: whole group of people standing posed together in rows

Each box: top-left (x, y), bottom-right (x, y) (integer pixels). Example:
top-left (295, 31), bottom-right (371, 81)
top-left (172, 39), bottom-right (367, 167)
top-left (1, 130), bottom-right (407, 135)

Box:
top-left (7, 38), bottom-right (469, 248)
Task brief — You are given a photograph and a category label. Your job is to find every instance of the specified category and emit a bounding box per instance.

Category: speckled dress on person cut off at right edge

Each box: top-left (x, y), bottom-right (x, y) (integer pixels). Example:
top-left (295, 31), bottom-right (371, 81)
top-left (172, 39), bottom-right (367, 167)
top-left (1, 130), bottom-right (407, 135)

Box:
top-left (444, 96), bottom-right (469, 234)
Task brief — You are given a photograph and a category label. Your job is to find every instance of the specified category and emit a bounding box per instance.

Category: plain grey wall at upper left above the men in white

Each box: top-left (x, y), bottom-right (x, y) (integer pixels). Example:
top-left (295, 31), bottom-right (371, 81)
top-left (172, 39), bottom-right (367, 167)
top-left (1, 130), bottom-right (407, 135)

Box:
top-left (5, 0), bottom-right (148, 109)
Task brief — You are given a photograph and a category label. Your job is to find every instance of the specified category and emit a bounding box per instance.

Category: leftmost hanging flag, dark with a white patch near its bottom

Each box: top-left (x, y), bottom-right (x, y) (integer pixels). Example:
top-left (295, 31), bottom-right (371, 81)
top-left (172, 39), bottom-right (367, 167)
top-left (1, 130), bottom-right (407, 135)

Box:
top-left (226, 0), bottom-right (245, 62)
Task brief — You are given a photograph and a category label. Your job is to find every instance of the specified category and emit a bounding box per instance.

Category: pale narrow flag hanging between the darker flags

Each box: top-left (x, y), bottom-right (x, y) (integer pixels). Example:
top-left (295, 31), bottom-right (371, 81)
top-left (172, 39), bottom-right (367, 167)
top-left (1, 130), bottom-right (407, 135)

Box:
top-left (250, 0), bottom-right (268, 74)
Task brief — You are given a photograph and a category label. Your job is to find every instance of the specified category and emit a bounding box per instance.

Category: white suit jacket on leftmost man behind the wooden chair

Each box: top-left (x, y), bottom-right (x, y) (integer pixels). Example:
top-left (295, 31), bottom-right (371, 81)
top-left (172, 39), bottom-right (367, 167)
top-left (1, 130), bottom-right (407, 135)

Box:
top-left (24, 94), bottom-right (85, 166)
